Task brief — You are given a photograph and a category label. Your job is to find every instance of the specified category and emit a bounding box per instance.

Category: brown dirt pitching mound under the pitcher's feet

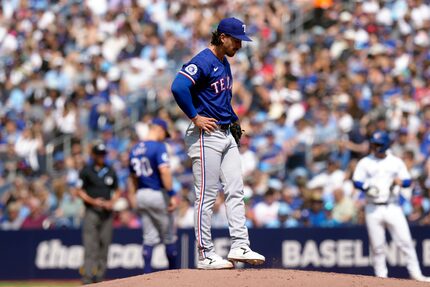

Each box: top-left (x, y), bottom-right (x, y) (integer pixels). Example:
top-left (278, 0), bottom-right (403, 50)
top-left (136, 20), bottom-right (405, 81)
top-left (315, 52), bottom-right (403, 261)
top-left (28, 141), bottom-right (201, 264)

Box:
top-left (86, 269), bottom-right (430, 287)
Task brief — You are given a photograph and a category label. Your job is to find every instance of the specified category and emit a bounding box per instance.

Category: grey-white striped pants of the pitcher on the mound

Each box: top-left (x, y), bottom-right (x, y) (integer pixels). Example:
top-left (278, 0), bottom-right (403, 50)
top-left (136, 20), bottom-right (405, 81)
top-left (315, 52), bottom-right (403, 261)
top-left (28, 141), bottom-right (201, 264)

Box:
top-left (185, 124), bottom-right (249, 259)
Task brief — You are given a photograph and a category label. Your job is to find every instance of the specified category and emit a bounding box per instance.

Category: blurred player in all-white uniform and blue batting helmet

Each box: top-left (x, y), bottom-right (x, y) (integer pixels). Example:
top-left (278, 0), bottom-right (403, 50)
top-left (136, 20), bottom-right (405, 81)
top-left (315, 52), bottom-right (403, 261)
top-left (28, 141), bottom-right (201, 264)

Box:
top-left (353, 131), bottom-right (430, 282)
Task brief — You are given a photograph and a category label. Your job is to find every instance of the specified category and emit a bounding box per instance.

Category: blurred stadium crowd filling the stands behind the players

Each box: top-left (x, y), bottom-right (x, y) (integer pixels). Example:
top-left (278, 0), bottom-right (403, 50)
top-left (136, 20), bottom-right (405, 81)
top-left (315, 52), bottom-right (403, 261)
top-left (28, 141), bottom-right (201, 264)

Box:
top-left (0, 0), bottom-right (430, 230)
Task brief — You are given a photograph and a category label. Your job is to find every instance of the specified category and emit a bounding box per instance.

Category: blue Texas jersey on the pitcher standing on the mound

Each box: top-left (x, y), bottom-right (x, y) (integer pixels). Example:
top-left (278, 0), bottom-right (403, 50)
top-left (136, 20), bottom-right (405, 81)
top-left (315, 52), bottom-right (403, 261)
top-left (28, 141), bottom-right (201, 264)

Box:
top-left (179, 48), bottom-right (238, 124)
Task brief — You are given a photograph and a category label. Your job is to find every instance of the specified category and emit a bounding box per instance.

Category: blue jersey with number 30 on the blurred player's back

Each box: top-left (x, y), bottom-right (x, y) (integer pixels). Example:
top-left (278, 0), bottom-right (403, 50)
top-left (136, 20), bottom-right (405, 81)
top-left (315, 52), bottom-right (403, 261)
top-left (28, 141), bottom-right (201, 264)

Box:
top-left (129, 141), bottom-right (169, 190)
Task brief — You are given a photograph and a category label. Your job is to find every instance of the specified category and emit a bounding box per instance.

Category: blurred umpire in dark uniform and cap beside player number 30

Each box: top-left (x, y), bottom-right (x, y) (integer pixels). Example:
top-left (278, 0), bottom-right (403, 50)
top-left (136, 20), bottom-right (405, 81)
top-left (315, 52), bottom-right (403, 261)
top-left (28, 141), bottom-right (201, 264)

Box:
top-left (78, 143), bottom-right (120, 284)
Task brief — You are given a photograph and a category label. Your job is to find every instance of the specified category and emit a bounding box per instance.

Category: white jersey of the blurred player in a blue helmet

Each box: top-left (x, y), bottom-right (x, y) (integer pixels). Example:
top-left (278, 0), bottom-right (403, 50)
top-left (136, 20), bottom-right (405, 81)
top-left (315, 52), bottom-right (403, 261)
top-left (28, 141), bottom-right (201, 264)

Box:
top-left (353, 153), bottom-right (411, 203)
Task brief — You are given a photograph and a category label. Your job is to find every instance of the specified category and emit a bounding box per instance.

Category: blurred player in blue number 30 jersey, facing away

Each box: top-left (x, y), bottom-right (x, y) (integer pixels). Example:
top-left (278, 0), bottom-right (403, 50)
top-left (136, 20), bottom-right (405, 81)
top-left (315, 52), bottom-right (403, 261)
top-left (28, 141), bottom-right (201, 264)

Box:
top-left (129, 118), bottom-right (177, 273)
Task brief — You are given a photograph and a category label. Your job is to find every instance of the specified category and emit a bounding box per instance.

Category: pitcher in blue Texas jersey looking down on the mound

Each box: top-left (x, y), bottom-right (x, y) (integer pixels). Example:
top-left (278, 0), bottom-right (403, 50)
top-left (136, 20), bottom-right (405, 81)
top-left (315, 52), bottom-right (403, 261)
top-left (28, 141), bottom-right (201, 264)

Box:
top-left (171, 18), bottom-right (265, 269)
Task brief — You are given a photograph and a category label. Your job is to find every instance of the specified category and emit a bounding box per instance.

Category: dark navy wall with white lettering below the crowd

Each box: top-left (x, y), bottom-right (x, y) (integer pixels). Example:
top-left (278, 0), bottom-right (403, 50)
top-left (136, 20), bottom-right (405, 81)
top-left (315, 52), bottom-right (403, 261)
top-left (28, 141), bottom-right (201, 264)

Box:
top-left (0, 227), bottom-right (430, 280)
